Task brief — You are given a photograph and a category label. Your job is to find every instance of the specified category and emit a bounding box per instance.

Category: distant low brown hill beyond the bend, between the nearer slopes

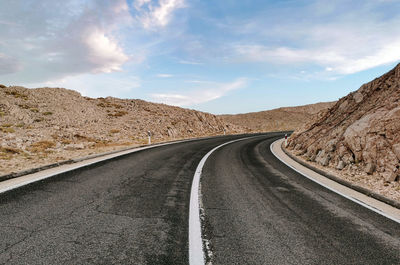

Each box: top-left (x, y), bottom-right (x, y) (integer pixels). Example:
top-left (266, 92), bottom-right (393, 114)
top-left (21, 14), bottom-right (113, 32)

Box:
top-left (220, 102), bottom-right (334, 132)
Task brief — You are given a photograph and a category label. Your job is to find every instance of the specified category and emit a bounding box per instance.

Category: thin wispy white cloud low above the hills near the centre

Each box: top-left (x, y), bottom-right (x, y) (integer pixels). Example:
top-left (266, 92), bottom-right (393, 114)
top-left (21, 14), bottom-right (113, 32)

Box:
top-left (151, 78), bottom-right (247, 106)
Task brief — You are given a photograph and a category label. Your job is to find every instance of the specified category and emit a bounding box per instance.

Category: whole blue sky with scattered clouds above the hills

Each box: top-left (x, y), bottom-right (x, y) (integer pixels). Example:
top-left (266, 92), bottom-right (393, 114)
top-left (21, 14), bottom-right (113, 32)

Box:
top-left (0, 0), bottom-right (400, 114)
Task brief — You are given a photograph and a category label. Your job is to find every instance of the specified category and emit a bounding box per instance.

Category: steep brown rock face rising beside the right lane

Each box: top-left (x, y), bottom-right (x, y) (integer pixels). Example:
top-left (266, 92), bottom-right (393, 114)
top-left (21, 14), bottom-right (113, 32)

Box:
top-left (288, 64), bottom-right (400, 181)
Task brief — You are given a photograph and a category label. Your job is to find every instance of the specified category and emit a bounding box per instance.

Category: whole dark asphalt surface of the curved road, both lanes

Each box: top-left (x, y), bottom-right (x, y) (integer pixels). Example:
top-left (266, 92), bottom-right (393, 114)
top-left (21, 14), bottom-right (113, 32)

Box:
top-left (0, 133), bottom-right (400, 264)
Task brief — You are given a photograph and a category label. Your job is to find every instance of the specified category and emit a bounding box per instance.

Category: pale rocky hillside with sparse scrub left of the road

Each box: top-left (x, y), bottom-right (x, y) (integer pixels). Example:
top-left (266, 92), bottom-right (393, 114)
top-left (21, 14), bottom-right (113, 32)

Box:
top-left (0, 85), bottom-right (245, 175)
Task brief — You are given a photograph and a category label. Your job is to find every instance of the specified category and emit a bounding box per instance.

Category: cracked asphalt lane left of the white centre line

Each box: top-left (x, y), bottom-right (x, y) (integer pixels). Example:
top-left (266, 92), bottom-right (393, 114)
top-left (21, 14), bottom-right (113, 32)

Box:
top-left (0, 136), bottom-right (247, 265)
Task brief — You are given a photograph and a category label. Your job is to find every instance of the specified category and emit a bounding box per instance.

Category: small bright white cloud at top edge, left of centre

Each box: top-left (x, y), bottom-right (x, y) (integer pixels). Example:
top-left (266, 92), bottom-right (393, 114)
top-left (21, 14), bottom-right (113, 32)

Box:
top-left (134, 0), bottom-right (185, 29)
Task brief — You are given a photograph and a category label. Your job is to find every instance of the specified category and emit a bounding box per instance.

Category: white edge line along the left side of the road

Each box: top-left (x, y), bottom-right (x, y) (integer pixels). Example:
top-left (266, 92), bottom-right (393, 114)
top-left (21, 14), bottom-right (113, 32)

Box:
top-left (0, 139), bottom-right (202, 194)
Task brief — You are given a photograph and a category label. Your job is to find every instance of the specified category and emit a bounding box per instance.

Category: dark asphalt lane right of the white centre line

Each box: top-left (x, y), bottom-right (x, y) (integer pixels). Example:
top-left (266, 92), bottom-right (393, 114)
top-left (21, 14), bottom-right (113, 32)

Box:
top-left (201, 136), bottom-right (400, 264)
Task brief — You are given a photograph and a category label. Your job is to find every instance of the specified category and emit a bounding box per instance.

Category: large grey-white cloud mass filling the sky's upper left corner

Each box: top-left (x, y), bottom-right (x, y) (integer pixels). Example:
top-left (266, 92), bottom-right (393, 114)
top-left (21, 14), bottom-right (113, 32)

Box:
top-left (0, 0), bottom-right (132, 83)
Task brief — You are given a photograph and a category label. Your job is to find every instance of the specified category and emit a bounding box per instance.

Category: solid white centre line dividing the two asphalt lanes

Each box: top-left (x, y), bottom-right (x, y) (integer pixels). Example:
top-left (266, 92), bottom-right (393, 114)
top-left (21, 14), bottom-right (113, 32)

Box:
top-left (189, 136), bottom-right (253, 265)
